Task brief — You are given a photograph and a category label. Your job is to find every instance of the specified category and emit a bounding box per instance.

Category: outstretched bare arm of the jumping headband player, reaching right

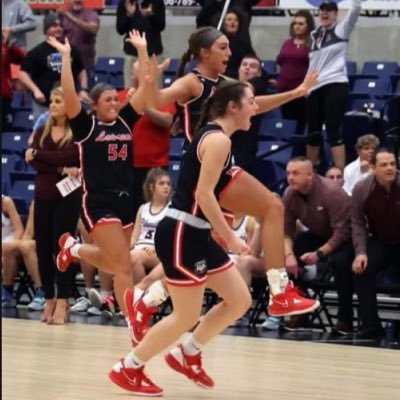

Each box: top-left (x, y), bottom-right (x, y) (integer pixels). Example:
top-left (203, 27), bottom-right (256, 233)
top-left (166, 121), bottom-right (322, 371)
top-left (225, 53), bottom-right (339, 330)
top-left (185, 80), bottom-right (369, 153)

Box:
top-left (256, 71), bottom-right (318, 114)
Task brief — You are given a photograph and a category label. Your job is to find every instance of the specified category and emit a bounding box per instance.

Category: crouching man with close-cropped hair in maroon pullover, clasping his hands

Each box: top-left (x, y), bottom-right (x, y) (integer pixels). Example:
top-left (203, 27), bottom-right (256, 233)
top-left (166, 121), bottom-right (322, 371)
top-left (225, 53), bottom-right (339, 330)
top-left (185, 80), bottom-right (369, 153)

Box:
top-left (283, 157), bottom-right (353, 335)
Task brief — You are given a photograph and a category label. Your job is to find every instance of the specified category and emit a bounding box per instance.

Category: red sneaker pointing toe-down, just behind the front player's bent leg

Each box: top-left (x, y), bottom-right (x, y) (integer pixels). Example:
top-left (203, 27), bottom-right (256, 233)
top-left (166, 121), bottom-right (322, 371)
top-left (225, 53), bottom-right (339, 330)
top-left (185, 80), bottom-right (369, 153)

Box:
top-left (124, 288), bottom-right (158, 347)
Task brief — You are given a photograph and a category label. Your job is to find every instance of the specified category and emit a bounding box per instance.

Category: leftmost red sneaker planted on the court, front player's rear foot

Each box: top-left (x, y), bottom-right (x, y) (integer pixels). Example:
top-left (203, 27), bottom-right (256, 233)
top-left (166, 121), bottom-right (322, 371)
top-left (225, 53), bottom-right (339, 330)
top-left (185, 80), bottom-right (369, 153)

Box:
top-left (108, 360), bottom-right (163, 396)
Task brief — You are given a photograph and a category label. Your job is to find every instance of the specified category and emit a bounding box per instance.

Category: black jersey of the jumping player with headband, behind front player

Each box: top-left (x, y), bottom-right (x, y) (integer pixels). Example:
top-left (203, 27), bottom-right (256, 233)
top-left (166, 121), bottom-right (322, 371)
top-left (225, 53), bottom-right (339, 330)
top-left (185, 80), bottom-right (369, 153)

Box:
top-left (176, 69), bottom-right (225, 142)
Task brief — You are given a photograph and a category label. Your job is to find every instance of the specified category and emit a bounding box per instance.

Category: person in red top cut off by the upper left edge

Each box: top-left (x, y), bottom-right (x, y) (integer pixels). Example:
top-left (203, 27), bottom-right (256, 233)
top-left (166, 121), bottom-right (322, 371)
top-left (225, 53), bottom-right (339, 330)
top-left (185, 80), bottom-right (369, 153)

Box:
top-left (1, 29), bottom-right (25, 132)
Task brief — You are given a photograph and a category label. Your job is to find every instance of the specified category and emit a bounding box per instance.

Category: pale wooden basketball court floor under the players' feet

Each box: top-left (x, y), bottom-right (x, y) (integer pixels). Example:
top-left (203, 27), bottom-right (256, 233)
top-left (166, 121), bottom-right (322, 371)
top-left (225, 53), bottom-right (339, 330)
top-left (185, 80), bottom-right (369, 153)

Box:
top-left (2, 318), bottom-right (400, 400)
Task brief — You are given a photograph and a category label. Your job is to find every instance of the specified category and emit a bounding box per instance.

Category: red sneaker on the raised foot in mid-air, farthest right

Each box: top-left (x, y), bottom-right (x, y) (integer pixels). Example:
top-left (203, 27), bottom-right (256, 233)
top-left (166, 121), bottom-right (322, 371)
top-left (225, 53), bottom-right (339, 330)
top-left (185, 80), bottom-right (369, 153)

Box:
top-left (268, 282), bottom-right (319, 317)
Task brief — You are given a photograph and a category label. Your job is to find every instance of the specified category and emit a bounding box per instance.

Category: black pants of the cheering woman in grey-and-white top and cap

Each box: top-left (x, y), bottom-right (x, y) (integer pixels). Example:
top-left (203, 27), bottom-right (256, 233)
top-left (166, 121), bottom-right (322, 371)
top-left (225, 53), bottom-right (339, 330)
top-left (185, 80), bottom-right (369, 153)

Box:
top-left (307, 83), bottom-right (349, 147)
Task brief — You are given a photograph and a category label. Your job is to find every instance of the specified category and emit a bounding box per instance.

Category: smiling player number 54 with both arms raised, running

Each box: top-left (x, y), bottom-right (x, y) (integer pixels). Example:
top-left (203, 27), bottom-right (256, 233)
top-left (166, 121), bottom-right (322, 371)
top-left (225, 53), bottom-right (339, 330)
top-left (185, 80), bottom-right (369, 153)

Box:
top-left (48, 31), bottom-right (155, 334)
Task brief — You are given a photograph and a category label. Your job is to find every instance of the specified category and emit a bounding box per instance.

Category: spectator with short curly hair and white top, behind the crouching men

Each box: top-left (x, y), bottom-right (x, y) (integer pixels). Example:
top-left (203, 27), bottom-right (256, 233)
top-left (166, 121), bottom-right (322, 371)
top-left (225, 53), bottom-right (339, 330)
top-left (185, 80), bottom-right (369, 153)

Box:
top-left (343, 134), bottom-right (379, 196)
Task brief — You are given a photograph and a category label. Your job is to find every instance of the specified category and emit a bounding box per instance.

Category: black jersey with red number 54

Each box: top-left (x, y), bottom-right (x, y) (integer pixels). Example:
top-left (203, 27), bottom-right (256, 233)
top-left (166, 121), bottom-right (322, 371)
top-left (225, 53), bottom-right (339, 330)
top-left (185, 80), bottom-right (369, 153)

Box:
top-left (70, 105), bottom-right (139, 194)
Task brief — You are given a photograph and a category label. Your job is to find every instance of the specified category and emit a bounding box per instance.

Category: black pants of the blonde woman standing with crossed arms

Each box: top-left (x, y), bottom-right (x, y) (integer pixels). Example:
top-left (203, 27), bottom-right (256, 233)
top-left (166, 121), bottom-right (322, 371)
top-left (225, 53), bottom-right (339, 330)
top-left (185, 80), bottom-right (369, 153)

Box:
top-left (34, 192), bottom-right (81, 299)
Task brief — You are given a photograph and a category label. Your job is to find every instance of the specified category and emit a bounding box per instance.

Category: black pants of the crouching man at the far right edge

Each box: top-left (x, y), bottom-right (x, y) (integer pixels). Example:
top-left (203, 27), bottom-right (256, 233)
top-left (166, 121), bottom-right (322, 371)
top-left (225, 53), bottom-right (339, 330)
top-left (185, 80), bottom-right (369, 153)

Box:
top-left (354, 238), bottom-right (400, 329)
